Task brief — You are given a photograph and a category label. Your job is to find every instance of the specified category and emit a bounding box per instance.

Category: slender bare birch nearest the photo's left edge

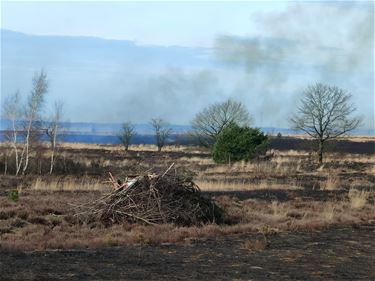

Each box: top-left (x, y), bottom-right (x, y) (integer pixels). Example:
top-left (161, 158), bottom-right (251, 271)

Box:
top-left (2, 91), bottom-right (22, 174)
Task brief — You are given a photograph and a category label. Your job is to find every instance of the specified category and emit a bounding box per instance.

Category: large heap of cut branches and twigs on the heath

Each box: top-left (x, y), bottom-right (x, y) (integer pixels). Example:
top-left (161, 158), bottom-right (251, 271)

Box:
top-left (75, 164), bottom-right (222, 226)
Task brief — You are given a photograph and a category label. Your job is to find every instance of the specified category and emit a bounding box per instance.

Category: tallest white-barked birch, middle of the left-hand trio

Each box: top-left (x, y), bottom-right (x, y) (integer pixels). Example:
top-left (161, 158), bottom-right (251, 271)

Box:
top-left (17, 70), bottom-right (48, 174)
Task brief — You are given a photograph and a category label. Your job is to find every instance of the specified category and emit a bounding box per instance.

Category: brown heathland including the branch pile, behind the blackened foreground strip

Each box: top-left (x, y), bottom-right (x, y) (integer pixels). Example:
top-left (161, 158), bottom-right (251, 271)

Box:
top-left (0, 140), bottom-right (375, 251)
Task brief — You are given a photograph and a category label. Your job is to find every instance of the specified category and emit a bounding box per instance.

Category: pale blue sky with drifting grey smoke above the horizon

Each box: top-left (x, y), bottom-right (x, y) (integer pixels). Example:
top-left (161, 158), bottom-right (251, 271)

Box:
top-left (1, 1), bottom-right (375, 128)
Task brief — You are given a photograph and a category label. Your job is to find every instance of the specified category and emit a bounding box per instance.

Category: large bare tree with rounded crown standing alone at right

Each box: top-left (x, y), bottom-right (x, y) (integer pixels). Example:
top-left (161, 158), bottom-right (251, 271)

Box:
top-left (291, 83), bottom-right (361, 163)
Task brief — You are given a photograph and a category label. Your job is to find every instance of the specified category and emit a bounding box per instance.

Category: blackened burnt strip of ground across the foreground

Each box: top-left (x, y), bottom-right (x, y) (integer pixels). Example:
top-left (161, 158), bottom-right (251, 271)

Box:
top-left (0, 225), bottom-right (375, 280)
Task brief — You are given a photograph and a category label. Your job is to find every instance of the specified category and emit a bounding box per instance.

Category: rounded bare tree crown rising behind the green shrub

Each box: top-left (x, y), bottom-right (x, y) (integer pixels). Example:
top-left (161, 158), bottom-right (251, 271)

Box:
top-left (191, 99), bottom-right (251, 146)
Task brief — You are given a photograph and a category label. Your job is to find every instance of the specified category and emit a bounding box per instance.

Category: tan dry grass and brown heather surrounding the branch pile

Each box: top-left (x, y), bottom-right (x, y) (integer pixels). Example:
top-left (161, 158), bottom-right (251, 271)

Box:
top-left (0, 144), bottom-right (375, 251)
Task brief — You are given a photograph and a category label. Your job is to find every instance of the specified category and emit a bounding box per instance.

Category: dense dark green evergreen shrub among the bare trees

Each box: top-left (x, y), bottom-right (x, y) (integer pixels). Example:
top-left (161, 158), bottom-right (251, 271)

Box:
top-left (213, 123), bottom-right (270, 163)
